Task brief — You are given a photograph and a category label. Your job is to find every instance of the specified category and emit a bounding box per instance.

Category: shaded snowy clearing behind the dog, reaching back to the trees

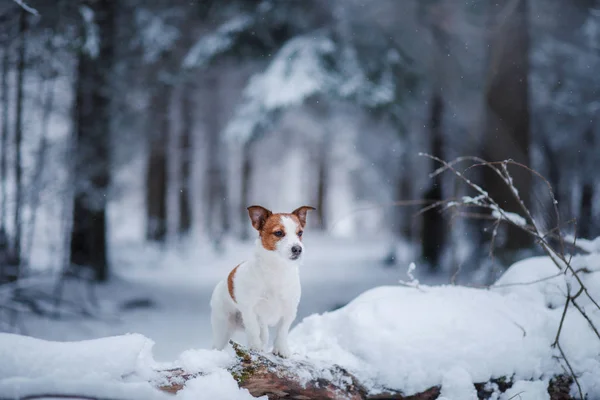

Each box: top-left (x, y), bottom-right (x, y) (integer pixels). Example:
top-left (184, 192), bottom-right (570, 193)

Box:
top-left (16, 234), bottom-right (406, 360)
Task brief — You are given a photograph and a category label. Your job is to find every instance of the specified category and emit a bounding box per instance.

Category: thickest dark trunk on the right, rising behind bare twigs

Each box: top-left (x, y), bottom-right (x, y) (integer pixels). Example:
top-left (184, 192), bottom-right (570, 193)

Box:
top-left (482, 0), bottom-right (532, 253)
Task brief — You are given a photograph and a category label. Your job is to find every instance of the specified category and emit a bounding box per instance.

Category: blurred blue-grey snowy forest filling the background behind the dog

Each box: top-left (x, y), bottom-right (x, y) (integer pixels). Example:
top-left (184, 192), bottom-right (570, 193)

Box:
top-left (0, 0), bottom-right (600, 346)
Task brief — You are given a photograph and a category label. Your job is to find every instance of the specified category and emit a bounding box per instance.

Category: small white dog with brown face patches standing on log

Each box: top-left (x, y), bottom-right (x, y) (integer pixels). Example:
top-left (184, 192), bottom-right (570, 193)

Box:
top-left (210, 206), bottom-right (315, 358)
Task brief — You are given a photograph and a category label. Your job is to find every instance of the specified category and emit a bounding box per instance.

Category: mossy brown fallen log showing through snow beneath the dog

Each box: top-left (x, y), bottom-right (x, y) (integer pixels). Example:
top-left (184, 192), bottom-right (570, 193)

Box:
top-left (158, 342), bottom-right (574, 400)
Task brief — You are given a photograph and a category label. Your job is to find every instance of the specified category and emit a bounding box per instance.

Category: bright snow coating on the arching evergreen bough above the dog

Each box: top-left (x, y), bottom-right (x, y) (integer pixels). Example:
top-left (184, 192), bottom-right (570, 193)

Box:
top-left (225, 30), bottom-right (406, 142)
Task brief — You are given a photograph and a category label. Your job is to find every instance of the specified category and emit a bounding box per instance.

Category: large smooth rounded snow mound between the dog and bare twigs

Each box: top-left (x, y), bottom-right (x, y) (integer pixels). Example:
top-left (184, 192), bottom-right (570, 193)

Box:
top-left (290, 286), bottom-right (552, 394)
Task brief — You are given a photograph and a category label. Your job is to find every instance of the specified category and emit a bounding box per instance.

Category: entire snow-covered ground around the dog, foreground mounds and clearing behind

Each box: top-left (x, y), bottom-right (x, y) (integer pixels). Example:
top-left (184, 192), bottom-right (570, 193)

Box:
top-left (0, 236), bottom-right (600, 400)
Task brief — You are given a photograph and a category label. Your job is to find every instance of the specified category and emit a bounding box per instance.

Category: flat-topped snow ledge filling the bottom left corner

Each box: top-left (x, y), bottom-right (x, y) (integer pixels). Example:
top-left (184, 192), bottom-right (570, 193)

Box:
top-left (0, 333), bottom-right (166, 399)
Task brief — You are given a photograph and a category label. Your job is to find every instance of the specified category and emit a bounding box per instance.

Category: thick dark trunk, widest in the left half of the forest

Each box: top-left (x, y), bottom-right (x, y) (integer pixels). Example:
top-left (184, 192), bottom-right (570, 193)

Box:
top-left (70, 0), bottom-right (117, 281)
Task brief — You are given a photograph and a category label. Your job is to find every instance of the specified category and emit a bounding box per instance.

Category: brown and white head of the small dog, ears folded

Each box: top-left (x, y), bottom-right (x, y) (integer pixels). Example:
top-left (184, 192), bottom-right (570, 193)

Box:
top-left (248, 206), bottom-right (315, 260)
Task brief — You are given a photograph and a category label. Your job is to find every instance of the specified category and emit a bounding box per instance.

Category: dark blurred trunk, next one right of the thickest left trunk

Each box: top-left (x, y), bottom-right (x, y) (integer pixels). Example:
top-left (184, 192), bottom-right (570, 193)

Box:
top-left (146, 83), bottom-right (172, 242)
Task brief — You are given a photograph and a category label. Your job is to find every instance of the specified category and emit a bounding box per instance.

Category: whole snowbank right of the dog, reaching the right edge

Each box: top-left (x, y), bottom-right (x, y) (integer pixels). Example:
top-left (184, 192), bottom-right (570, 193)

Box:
top-left (290, 257), bottom-right (600, 399)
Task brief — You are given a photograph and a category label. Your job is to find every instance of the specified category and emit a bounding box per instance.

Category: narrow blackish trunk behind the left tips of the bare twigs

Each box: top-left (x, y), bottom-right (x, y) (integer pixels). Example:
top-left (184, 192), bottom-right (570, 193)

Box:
top-left (421, 91), bottom-right (446, 271)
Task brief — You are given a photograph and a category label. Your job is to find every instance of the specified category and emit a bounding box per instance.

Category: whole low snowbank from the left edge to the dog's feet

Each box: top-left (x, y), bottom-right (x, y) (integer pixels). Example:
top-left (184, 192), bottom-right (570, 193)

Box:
top-left (0, 333), bottom-right (262, 400)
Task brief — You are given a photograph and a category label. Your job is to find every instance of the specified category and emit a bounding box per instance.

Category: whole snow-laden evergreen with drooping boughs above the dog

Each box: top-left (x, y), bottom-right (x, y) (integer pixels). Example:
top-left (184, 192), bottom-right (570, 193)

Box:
top-left (184, 1), bottom-right (417, 238)
